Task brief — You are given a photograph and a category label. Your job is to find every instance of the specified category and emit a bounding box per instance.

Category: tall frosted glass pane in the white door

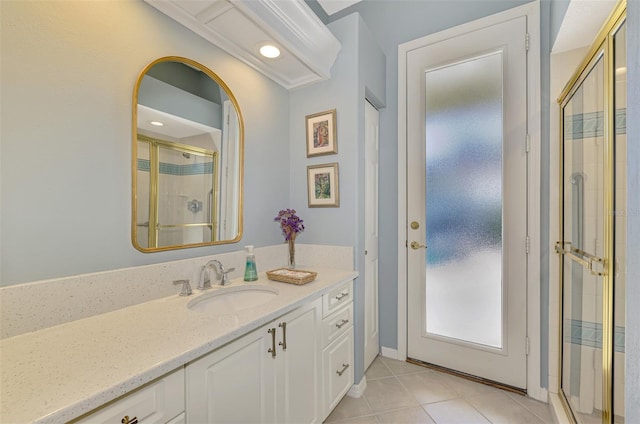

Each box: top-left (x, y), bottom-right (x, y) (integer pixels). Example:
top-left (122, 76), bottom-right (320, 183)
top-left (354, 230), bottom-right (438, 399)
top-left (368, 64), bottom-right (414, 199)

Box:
top-left (425, 52), bottom-right (503, 348)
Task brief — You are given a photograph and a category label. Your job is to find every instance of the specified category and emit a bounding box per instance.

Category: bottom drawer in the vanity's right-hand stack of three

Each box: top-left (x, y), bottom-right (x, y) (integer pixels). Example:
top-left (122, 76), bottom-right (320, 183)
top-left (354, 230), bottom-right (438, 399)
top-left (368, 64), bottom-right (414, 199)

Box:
top-left (322, 329), bottom-right (353, 413)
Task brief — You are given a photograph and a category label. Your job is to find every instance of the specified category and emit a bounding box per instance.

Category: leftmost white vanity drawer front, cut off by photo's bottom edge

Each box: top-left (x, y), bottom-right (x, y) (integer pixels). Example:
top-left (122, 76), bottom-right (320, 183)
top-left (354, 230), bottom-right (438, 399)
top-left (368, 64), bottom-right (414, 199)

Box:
top-left (75, 368), bottom-right (184, 424)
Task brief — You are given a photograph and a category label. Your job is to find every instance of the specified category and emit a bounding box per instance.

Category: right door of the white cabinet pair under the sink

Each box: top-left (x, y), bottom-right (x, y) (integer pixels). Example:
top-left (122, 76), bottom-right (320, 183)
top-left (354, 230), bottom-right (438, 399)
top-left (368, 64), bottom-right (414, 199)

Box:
top-left (276, 299), bottom-right (322, 424)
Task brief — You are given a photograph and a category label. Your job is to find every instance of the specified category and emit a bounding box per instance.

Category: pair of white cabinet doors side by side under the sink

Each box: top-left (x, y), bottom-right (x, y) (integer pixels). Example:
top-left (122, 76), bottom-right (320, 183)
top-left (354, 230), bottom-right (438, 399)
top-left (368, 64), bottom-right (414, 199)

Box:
top-left (186, 299), bottom-right (322, 424)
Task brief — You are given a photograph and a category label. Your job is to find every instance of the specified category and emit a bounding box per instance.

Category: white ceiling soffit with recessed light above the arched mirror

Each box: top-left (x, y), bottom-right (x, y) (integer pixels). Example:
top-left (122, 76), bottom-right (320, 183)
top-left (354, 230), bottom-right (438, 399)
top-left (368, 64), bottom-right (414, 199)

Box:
top-left (145, 0), bottom-right (342, 89)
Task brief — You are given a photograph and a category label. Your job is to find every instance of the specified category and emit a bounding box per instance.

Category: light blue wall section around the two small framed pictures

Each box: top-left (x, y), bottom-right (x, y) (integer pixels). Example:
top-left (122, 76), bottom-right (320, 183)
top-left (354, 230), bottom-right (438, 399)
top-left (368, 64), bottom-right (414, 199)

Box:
top-left (289, 14), bottom-right (386, 382)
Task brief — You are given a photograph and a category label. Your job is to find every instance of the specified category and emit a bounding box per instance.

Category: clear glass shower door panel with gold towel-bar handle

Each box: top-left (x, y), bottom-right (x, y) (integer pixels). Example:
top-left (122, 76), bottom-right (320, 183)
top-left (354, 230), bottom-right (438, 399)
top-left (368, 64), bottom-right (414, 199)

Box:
top-left (559, 55), bottom-right (605, 422)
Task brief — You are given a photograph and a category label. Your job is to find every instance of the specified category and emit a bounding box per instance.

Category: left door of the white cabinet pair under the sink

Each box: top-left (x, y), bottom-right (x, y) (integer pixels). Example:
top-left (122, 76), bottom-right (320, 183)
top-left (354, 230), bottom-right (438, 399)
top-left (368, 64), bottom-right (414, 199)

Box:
top-left (187, 325), bottom-right (277, 424)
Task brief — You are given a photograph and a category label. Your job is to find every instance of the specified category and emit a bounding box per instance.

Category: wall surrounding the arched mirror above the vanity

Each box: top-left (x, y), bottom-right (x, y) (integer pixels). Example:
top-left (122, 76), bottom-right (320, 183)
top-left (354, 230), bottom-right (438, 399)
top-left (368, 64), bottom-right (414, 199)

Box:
top-left (0, 1), bottom-right (288, 285)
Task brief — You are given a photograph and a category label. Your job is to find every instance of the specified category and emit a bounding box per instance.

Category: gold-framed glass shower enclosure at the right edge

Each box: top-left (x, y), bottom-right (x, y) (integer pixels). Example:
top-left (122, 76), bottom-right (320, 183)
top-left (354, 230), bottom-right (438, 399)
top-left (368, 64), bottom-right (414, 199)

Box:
top-left (556, 2), bottom-right (626, 423)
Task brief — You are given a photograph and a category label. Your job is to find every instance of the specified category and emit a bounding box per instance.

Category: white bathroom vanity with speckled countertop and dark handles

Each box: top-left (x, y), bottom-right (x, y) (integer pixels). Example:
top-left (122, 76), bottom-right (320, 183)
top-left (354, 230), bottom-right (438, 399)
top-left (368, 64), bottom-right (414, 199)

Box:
top-left (0, 267), bottom-right (357, 423)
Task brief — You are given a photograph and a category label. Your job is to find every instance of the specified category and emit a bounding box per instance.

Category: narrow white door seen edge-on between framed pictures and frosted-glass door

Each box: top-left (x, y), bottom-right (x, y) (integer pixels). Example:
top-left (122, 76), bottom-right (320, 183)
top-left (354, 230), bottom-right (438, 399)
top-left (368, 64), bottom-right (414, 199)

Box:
top-left (364, 101), bottom-right (380, 369)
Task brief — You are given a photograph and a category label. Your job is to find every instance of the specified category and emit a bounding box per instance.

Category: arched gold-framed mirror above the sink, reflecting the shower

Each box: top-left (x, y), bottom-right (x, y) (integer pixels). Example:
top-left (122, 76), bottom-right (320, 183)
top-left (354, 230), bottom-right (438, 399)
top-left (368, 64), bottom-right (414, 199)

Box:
top-left (131, 56), bottom-right (244, 252)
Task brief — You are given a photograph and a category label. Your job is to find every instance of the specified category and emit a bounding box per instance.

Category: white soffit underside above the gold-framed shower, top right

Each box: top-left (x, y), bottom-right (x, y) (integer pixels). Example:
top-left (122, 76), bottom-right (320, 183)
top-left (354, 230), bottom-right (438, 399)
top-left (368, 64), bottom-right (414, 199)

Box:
top-left (552, 0), bottom-right (617, 53)
